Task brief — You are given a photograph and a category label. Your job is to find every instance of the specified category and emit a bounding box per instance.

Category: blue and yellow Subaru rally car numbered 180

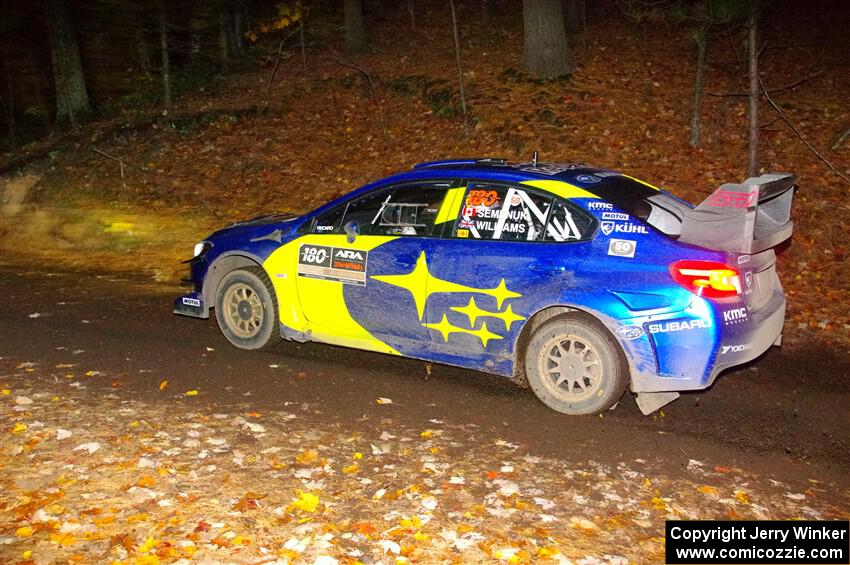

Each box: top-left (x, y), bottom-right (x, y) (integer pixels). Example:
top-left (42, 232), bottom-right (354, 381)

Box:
top-left (174, 158), bottom-right (796, 414)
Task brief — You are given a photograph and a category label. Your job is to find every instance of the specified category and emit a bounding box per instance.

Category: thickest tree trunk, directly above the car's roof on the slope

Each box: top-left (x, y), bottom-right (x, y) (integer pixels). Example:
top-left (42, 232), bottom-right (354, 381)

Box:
top-left (522, 0), bottom-right (573, 78)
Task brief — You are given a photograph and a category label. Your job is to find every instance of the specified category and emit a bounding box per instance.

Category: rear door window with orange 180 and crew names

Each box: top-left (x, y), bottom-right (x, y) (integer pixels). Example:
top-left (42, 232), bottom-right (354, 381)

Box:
top-left (454, 183), bottom-right (552, 241)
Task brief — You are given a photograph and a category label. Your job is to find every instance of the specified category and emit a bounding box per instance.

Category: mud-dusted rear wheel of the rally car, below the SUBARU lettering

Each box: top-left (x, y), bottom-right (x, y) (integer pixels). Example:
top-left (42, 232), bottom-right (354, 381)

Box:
top-left (525, 314), bottom-right (628, 415)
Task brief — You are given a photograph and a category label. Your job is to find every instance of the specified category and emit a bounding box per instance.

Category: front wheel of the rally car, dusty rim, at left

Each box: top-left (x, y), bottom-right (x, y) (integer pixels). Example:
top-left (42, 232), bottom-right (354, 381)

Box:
top-left (215, 267), bottom-right (281, 349)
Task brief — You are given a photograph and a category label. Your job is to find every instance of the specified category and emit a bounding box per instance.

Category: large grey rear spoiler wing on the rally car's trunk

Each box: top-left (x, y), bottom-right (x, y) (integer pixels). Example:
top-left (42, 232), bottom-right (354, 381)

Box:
top-left (679, 173), bottom-right (797, 255)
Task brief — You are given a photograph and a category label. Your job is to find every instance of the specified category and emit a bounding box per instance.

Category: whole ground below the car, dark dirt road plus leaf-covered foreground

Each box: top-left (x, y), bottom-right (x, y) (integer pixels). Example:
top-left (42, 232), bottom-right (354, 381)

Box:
top-left (0, 265), bottom-right (850, 563)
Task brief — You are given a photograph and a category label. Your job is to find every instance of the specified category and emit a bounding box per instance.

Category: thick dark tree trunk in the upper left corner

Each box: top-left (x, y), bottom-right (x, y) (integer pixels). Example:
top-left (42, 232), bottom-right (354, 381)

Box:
top-left (47, 0), bottom-right (91, 126)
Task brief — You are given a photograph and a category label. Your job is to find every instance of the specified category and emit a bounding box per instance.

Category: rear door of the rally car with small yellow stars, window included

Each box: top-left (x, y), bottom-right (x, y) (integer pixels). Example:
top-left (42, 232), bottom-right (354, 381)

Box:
top-left (424, 182), bottom-right (596, 375)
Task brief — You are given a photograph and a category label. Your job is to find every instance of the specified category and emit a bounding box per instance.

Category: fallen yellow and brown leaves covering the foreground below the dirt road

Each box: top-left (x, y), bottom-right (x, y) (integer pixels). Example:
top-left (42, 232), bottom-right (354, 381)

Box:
top-left (0, 362), bottom-right (850, 564)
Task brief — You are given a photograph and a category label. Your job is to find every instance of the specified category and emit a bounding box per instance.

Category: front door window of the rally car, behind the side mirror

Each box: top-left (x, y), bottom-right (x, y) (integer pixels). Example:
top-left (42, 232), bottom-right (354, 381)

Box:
top-left (342, 183), bottom-right (449, 236)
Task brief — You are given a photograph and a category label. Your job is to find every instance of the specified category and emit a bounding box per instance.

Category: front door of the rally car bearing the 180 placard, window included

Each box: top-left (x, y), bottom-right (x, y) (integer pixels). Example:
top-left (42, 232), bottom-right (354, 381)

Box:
top-left (293, 181), bottom-right (453, 357)
